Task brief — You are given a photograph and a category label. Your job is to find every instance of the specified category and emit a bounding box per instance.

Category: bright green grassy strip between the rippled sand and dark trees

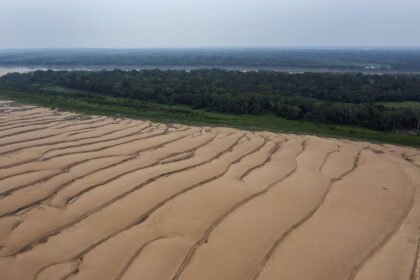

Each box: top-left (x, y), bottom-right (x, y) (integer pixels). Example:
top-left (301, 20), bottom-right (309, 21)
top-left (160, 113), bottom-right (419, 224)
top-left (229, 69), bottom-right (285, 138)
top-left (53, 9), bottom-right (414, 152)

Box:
top-left (0, 86), bottom-right (420, 147)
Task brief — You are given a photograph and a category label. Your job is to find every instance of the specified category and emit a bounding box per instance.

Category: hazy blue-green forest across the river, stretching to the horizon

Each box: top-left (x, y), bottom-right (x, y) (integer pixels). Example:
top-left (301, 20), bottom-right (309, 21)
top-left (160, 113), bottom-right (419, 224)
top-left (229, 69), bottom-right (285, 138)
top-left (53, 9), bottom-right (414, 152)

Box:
top-left (0, 48), bottom-right (420, 72)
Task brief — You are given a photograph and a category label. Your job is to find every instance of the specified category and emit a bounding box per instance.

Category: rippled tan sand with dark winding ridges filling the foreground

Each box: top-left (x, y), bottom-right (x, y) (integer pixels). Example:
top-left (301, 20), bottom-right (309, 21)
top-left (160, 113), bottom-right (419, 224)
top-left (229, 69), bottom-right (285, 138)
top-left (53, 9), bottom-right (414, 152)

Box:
top-left (0, 101), bottom-right (420, 280)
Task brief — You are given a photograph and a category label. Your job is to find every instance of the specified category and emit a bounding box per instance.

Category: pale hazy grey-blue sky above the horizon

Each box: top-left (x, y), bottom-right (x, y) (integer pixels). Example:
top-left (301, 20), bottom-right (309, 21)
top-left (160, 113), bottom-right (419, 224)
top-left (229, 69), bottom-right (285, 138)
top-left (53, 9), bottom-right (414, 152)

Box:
top-left (0, 0), bottom-right (420, 48)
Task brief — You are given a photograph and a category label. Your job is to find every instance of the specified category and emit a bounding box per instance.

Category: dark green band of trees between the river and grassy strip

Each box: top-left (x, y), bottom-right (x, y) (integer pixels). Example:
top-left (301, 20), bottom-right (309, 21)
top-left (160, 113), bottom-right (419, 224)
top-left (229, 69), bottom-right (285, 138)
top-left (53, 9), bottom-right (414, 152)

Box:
top-left (0, 69), bottom-right (420, 131)
